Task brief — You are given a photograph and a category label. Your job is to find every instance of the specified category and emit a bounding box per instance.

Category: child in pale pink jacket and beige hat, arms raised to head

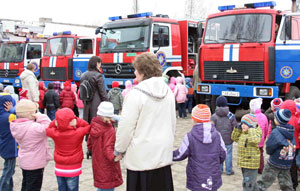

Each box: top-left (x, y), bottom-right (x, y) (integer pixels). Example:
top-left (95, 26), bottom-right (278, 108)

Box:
top-left (10, 99), bottom-right (51, 191)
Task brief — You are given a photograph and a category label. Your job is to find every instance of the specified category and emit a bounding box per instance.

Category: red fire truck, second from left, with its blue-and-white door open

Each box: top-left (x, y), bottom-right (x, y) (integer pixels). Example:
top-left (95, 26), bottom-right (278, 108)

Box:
top-left (41, 31), bottom-right (100, 84)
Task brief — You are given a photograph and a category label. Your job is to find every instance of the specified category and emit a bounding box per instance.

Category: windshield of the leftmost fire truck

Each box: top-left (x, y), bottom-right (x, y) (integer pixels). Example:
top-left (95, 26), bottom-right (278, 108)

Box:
top-left (0, 43), bottom-right (25, 62)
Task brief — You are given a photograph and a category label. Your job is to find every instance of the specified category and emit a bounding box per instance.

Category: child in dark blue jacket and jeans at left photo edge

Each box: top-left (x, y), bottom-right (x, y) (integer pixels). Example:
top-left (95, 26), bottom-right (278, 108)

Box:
top-left (0, 93), bottom-right (18, 191)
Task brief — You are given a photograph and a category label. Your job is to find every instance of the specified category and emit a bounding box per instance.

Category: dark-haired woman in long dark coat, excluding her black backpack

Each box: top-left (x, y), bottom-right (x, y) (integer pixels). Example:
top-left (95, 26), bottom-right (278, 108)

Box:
top-left (80, 56), bottom-right (108, 123)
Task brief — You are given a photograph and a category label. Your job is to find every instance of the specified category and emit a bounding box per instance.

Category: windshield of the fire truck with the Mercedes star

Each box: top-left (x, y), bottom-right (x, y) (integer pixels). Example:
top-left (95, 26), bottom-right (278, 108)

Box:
top-left (100, 26), bottom-right (150, 52)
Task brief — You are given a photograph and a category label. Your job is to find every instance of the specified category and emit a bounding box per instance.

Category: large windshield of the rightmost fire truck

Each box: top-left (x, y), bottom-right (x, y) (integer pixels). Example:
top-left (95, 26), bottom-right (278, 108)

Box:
top-left (204, 14), bottom-right (272, 44)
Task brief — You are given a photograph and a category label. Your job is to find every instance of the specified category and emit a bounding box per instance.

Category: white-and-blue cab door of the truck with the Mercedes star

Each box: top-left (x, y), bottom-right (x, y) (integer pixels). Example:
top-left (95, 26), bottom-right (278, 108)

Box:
top-left (150, 23), bottom-right (173, 70)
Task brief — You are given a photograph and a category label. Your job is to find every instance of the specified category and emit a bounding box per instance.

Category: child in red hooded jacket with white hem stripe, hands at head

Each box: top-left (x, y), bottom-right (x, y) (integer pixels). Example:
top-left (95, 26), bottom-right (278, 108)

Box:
top-left (46, 108), bottom-right (90, 191)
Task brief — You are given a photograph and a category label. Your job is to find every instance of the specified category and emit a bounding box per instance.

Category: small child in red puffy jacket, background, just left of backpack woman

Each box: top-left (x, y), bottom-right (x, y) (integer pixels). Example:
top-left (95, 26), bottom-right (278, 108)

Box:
top-left (59, 81), bottom-right (76, 109)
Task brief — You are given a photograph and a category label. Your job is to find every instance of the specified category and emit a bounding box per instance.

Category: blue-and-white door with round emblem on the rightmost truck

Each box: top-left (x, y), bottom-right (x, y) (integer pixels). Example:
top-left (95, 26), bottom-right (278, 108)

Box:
top-left (275, 13), bottom-right (300, 83)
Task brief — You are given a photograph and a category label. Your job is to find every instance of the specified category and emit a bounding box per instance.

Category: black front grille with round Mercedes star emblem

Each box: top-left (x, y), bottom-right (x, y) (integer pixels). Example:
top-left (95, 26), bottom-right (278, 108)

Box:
top-left (101, 63), bottom-right (135, 78)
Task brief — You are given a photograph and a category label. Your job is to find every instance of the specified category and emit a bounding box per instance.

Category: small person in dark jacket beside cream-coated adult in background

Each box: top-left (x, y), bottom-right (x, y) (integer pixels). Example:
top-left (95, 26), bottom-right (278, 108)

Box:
top-left (43, 83), bottom-right (60, 120)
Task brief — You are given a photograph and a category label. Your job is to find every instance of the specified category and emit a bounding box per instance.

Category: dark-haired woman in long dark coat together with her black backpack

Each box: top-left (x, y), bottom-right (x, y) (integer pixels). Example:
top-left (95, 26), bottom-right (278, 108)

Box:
top-left (79, 56), bottom-right (108, 123)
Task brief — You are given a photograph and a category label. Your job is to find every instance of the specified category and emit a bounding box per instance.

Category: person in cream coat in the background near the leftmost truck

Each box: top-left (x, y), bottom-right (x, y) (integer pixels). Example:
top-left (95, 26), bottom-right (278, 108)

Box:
top-left (20, 64), bottom-right (40, 103)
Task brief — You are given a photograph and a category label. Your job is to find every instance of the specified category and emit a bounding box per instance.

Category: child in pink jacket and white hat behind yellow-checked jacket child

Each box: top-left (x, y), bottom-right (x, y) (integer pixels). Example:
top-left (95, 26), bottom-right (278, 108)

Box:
top-left (249, 98), bottom-right (269, 174)
